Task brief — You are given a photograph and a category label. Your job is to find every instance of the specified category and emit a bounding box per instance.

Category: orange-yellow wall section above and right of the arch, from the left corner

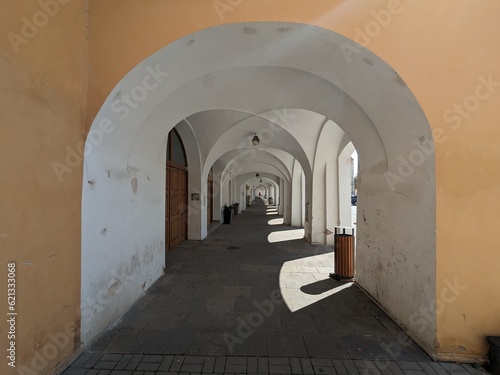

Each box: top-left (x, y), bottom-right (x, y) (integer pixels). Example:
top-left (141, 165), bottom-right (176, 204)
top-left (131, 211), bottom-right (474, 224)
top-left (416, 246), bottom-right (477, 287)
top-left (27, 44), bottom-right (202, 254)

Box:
top-left (87, 0), bottom-right (500, 359)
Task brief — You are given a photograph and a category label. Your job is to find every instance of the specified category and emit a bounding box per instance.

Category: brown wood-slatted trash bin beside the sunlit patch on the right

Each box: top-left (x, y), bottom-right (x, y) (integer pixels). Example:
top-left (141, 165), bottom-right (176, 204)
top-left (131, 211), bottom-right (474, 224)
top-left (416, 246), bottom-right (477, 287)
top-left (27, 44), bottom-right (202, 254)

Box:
top-left (330, 228), bottom-right (355, 281)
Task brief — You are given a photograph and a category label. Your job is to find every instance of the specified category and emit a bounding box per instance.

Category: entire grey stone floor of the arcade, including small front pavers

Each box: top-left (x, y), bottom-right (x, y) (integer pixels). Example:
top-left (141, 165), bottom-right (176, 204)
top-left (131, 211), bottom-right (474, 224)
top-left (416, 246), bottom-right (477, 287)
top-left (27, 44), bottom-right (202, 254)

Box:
top-left (64, 203), bottom-right (487, 375)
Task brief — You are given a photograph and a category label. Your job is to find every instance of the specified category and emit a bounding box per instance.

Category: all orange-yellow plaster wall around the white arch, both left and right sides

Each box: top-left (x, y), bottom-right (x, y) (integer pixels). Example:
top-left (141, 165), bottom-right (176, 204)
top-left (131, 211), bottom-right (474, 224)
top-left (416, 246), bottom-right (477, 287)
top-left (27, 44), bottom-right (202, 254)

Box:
top-left (0, 0), bottom-right (500, 374)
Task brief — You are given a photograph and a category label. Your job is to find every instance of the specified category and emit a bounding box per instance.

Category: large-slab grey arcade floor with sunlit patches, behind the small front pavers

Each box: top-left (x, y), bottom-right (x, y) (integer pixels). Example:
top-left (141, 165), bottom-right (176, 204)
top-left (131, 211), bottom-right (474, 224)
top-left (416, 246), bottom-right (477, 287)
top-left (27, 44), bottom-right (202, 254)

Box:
top-left (91, 202), bottom-right (430, 361)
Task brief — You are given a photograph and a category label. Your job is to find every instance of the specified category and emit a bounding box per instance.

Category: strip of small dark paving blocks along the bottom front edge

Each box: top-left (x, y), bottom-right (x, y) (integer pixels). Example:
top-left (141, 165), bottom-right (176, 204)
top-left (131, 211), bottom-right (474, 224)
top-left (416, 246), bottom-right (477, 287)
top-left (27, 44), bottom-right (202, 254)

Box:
top-left (63, 352), bottom-right (488, 375)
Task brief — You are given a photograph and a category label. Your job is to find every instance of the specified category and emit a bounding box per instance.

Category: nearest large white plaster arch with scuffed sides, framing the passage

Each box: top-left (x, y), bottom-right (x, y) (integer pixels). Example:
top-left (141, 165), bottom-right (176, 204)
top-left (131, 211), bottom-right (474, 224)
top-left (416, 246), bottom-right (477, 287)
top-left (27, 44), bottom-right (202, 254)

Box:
top-left (82, 23), bottom-right (436, 352)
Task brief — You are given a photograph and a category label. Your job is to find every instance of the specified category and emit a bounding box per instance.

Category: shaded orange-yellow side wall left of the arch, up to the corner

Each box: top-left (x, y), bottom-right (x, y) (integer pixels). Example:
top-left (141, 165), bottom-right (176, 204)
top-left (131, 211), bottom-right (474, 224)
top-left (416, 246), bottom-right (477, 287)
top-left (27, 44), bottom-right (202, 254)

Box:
top-left (0, 0), bottom-right (88, 374)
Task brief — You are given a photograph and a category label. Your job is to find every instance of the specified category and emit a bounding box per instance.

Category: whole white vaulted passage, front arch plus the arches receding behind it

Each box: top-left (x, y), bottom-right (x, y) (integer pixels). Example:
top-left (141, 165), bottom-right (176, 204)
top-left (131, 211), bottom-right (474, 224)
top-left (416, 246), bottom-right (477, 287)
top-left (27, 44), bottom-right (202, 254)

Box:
top-left (82, 23), bottom-right (436, 352)
